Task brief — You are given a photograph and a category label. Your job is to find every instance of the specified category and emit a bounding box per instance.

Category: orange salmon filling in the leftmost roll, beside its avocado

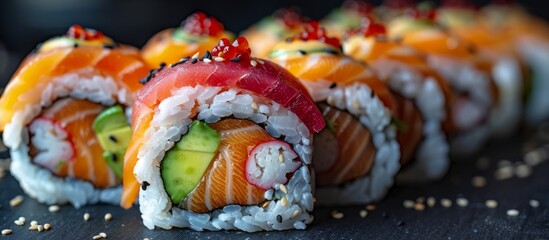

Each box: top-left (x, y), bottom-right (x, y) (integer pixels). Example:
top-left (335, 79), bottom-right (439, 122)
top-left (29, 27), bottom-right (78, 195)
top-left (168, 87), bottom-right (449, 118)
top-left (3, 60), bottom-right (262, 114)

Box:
top-left (31, 98), bottom-right (120, 188)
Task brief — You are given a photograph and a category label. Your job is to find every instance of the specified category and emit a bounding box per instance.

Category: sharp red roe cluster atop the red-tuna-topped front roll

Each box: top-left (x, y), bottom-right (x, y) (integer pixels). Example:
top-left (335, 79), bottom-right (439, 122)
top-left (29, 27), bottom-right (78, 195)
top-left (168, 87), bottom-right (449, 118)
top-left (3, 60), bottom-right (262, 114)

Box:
top-left (212, 37), bottom-right (252, 62)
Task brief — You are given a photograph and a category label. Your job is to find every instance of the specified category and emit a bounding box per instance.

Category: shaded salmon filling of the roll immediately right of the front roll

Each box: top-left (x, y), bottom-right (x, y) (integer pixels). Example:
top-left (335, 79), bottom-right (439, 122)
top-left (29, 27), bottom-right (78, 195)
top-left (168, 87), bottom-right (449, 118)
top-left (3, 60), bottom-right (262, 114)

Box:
top-left (313, 103), bottom-right (376, 187)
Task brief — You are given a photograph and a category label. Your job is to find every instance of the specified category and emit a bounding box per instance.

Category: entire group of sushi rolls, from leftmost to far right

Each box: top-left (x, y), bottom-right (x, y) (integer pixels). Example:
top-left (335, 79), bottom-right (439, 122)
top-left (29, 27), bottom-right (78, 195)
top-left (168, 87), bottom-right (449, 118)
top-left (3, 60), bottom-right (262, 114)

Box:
top-left (0, 0), bottom-right (549, 232)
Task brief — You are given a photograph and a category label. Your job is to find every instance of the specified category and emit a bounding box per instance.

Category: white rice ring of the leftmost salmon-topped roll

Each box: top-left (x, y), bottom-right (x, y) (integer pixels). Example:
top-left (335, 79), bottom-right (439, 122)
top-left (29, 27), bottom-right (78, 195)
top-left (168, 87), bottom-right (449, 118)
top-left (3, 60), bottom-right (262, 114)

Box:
top-left (3, 69), bottom-right (133, 208)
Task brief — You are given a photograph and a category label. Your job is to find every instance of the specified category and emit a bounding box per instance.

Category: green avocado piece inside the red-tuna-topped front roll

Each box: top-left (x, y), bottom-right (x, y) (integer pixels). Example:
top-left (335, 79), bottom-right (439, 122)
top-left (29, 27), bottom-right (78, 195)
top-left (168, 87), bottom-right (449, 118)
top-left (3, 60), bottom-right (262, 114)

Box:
top-left (161, 121), bottom-right (221, 204)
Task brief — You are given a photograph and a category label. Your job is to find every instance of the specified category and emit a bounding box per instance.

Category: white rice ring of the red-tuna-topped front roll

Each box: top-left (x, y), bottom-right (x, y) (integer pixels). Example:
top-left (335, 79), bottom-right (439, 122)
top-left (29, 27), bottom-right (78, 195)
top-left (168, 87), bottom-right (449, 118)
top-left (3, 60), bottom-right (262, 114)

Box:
top-left (134, 85), bottom-right (314, 232)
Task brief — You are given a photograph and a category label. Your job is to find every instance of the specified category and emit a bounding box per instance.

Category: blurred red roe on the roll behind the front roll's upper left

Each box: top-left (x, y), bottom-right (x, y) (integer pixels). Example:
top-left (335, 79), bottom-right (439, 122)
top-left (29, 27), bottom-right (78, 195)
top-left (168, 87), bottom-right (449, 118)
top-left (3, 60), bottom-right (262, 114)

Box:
top-left (181, 12), bottom-right (224, 36)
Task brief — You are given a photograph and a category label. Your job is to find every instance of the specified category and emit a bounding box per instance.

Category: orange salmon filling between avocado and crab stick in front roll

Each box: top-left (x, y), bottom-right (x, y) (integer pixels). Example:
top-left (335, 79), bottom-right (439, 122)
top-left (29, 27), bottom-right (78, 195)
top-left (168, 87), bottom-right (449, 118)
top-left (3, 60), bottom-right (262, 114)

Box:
top-left (182, 119), bottom-right (274, 213)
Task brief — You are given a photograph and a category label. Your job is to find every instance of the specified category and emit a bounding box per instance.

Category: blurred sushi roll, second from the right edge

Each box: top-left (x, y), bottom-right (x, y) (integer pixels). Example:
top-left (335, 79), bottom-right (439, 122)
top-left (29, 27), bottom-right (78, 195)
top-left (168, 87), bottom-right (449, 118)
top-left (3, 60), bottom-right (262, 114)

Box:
top-left (436, 0), bottom-right (526, 137)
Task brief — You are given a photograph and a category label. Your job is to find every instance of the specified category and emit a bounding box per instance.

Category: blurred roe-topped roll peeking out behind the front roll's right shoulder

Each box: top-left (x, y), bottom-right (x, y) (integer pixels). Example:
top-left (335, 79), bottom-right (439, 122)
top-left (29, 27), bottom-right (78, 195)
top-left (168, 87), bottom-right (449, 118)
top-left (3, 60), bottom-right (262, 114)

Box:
top-left (241, 8), bottom-right (304, 58)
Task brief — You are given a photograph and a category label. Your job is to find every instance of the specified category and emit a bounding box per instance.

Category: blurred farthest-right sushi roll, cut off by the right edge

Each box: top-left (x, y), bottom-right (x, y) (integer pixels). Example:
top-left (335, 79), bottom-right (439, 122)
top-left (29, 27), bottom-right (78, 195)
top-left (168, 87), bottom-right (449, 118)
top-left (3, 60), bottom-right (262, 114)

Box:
top-left (481, 1), bottom-right (549, 124)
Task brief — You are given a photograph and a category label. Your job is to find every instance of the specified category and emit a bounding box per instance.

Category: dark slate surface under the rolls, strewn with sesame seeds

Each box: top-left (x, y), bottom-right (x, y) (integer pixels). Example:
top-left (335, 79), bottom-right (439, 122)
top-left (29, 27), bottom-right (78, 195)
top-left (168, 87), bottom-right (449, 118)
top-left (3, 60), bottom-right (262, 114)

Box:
top-left (0, 125), bottom-right (549, 239)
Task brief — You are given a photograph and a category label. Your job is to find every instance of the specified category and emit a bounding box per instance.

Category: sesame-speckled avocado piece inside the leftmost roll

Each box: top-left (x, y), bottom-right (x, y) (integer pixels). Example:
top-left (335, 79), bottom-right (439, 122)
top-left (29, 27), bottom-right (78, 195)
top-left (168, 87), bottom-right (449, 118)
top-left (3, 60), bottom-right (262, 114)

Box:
top-left (92, 105), bottom-right (132, 178)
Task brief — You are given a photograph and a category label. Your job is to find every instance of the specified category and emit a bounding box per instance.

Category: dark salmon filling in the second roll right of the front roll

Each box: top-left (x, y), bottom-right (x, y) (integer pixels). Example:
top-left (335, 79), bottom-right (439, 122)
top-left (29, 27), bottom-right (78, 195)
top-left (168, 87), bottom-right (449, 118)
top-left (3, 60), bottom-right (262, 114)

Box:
top-left (393, 94), bottom-right (423, 166)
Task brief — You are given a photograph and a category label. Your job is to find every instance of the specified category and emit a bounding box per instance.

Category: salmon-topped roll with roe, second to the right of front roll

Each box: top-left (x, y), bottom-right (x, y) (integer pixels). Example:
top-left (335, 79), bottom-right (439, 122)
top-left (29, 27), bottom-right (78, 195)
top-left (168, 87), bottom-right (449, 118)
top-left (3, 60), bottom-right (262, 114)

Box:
top-left (343, 18), bottom-right (451, 182)
